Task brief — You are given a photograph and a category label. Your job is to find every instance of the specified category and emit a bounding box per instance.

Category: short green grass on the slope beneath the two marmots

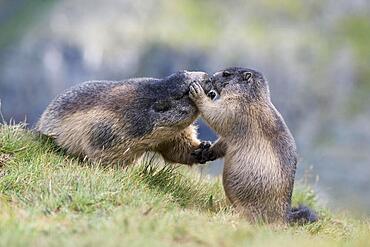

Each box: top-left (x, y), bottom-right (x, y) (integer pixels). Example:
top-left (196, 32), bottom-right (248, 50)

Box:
top-left (0, 125), bottom-right (370, 247)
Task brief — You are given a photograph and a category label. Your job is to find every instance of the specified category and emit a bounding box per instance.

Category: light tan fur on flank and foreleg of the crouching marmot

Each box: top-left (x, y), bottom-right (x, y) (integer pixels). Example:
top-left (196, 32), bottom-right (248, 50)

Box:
top-left (45, 108), bottom-right (204, 166)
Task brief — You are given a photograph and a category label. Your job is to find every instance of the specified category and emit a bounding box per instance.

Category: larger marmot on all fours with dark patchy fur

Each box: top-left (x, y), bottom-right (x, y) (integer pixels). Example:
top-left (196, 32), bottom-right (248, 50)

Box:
top-left (36, 71), bottom-right (209, 166)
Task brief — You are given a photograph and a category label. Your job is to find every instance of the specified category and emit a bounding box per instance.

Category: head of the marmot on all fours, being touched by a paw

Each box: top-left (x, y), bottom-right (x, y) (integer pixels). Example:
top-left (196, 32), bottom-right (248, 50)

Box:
top-left (153, 71), bottom-right (212, 128)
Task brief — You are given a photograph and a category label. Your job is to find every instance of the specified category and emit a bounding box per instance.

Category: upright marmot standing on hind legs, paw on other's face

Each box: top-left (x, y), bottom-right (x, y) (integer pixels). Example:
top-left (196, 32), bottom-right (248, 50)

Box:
top-left (190, 68), bottom-right (316, 222)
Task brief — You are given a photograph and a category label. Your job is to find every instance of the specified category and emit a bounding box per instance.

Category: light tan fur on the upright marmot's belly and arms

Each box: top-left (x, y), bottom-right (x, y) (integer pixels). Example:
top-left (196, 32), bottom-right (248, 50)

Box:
top-left (190, 77), bottom-right (294, 222)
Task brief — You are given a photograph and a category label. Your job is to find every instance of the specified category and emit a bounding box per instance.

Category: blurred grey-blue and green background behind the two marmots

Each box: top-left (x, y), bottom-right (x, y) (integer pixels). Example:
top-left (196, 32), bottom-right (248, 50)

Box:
top-left (0, 0), bottom-right (370, 215)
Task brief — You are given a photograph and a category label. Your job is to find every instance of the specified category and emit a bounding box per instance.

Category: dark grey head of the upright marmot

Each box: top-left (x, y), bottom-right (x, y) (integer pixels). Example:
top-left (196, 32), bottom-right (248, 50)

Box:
top-left (211, 67), bottom-right (270, 102)
